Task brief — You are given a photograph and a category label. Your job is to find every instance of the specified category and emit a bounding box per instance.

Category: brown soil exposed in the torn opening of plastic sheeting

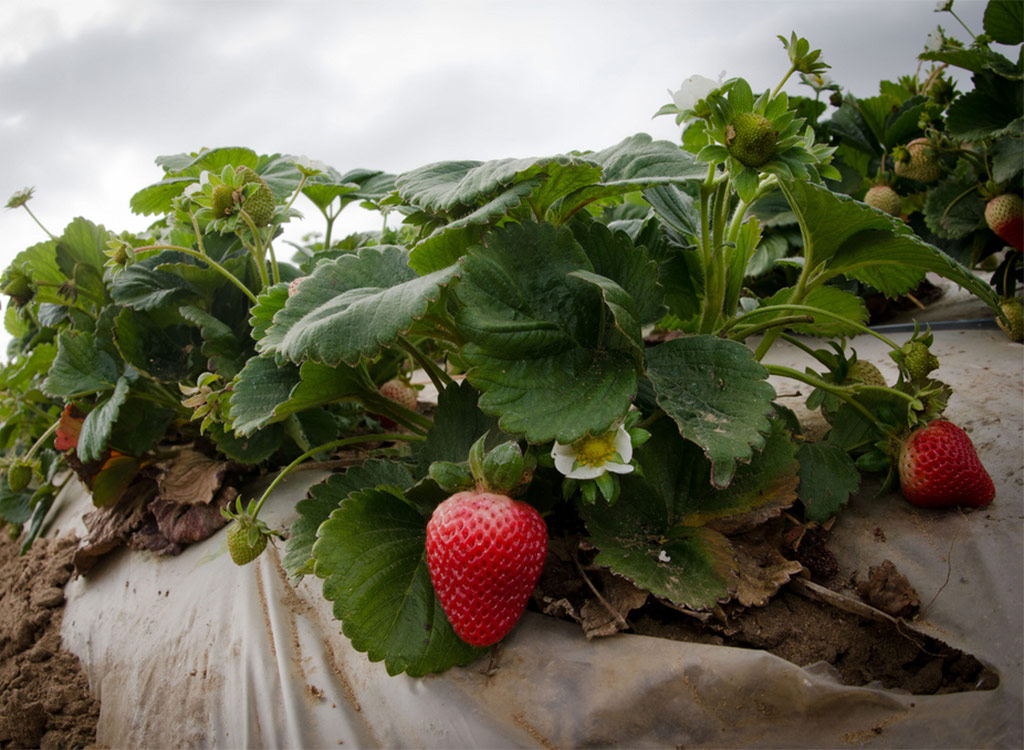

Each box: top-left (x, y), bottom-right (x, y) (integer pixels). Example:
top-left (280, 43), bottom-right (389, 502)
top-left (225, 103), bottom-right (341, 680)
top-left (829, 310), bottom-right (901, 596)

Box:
top-left (534, 528), bottom-right (999, 695)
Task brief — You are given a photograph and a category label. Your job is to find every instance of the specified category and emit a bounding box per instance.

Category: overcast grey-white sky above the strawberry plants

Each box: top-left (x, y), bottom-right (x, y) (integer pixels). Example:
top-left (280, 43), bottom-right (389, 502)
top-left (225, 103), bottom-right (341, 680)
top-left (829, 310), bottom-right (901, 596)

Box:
top-left (0, 0), bottom-right (985, 357)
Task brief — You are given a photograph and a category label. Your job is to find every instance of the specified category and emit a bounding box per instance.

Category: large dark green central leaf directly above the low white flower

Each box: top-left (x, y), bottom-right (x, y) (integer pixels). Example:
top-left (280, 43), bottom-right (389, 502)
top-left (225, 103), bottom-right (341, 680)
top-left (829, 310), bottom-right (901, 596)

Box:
top-left (457, 223), bottom-right (637, 443)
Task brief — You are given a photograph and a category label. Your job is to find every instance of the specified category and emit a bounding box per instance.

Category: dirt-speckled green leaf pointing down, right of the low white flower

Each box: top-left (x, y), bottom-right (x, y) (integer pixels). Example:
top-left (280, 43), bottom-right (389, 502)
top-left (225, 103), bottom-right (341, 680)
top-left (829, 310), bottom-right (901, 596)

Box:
top-left (647, 336), bottom-right (775, 488)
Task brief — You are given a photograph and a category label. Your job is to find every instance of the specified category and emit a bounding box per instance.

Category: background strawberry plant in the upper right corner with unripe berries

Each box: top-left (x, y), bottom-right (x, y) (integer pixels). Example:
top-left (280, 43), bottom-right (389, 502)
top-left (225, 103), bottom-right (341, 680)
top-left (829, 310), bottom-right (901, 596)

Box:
top-left (819, 2), bottom-right (1024, 325)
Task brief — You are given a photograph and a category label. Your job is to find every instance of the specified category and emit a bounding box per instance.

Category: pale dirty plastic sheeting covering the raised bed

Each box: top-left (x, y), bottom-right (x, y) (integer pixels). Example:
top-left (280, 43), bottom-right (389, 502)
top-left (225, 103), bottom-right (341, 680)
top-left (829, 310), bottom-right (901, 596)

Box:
top-left (51, 290), bottom-right (1024, 748)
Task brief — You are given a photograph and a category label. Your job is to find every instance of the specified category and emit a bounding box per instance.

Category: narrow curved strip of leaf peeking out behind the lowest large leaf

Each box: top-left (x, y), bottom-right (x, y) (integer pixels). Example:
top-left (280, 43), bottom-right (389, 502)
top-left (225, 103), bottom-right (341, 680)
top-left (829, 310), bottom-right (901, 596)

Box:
top-left (281, 460), bottom-right (413, 575)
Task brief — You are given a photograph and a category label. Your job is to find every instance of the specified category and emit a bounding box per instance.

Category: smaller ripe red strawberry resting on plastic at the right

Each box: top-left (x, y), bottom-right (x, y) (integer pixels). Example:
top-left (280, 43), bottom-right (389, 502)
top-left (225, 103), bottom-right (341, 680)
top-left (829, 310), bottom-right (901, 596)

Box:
top-left (899, 419), bottom-right (995, 508)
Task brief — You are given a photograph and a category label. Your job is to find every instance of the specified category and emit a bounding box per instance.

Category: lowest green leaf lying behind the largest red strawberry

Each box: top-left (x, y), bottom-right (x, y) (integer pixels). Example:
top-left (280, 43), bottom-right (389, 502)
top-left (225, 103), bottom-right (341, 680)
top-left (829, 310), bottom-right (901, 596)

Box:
top-left (313, 490), bottom-right (482, 677)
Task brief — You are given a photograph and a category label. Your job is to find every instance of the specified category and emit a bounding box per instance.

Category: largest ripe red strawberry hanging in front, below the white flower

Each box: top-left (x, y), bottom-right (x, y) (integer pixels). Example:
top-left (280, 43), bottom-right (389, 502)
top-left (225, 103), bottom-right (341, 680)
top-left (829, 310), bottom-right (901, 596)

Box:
top-left (427, 490), bottom-right (548, 647)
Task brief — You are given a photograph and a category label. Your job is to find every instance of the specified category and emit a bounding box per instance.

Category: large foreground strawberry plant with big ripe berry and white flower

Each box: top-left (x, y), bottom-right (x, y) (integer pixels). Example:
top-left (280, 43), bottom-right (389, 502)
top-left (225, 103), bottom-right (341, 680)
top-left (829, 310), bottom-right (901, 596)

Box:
top-left (0, 2), bottom-right (999, 675)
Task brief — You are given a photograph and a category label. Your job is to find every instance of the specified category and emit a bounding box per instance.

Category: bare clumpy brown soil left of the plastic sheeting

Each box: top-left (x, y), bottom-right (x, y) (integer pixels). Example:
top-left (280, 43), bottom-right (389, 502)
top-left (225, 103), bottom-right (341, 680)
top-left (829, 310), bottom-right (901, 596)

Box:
top-left (0, 534), bottom-right (99, 748)
